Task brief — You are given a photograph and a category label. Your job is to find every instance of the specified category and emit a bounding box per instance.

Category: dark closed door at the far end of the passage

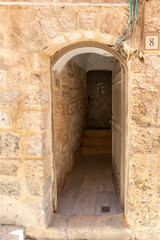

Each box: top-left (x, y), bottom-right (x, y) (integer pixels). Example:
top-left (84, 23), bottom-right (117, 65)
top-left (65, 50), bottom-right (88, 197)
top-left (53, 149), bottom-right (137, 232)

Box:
top-left (87, 71), bottom-right (112, 129)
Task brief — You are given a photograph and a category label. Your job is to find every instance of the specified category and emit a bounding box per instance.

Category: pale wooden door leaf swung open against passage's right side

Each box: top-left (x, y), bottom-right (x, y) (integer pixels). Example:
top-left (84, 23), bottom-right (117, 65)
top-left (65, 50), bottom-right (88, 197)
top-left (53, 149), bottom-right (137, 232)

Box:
top-left (112, 60), bottom-right (125, 207)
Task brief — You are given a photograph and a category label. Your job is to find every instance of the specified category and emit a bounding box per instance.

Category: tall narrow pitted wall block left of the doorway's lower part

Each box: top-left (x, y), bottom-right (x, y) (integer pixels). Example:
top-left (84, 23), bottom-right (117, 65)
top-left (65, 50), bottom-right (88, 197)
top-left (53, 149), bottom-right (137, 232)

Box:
top-left (24, 160), bottom-right (44, 197)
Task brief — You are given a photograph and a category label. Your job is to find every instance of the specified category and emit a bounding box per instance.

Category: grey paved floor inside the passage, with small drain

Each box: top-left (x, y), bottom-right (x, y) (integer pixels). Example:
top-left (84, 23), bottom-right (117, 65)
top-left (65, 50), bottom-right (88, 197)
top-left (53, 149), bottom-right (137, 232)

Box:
top-left (57, 156), bottom-right (122, 216)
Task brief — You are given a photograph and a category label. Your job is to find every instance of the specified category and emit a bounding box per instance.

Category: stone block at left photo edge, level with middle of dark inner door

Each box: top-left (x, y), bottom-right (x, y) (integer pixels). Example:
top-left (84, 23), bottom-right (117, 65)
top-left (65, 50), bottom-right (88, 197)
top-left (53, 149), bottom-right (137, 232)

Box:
top-left (0, 89), bottom-right (21, 108)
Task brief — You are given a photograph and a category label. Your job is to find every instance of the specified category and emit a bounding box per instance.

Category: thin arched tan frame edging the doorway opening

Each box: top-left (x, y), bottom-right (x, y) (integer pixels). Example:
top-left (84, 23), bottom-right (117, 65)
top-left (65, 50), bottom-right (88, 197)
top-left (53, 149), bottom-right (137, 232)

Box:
top-left (50, 41), bottom-right (129, 212)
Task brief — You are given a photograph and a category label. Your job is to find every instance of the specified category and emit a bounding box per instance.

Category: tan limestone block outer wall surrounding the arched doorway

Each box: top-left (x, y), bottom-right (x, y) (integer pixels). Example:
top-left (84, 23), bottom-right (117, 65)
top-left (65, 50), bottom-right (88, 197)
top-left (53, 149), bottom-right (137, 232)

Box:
top-left (0, 0), bottom-right (160, 239)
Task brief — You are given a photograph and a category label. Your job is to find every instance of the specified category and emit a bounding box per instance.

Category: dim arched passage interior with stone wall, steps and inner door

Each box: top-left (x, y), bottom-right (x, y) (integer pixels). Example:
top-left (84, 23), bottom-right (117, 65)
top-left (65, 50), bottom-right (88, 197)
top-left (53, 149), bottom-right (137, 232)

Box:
top-left (52, 45), bottom-right (126, 215)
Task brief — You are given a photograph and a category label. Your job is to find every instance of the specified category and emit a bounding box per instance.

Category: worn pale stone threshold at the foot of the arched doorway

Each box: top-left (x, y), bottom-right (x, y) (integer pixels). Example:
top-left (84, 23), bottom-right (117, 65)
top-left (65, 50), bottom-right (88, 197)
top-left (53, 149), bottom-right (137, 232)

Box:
top-left (25, 214), bottom-right (132, 240)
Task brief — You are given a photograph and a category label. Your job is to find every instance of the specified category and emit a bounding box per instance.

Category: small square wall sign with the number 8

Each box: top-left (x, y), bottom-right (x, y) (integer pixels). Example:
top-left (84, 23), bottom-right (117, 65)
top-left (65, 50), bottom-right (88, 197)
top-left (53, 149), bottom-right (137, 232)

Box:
top-left (144, 35), bottom-right (159, 50)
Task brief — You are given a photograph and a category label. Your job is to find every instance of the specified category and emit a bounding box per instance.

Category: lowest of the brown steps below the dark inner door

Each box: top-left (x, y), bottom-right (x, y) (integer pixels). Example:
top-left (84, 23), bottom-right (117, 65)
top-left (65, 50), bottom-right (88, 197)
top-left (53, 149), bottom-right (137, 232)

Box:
top-left (81, 147), bottom-right (112, 155)
